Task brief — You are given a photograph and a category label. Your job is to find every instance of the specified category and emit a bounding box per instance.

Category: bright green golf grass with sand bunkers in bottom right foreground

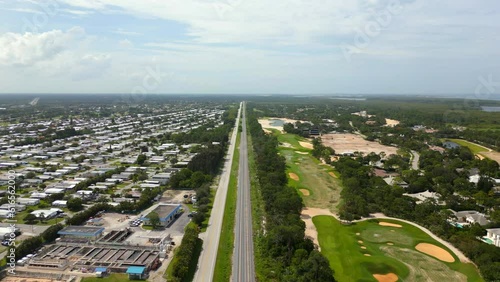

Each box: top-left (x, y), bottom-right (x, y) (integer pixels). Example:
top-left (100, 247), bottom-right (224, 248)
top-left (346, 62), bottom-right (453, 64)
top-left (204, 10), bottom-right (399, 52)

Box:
top-left (313, 215), bottom-right (483, 282)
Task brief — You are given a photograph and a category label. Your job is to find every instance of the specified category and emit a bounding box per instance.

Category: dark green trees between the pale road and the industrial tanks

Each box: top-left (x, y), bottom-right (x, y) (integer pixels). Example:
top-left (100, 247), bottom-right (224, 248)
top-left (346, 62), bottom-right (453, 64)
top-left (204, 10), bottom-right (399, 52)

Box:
top-left (169, 225), bottom-right (201, 282)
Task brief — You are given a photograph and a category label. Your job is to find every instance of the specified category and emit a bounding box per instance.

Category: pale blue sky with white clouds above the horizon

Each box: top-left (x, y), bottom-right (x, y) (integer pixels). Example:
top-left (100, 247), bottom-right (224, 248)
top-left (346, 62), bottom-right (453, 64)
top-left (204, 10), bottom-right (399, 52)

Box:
top-left (0, 0), bottom-right (500, 97)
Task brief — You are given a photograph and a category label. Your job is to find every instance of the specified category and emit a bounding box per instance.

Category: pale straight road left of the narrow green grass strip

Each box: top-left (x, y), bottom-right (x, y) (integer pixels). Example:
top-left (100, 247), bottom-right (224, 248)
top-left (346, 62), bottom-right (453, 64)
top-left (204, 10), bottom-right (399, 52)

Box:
top-left (193, 104), bottom-right (242, 282)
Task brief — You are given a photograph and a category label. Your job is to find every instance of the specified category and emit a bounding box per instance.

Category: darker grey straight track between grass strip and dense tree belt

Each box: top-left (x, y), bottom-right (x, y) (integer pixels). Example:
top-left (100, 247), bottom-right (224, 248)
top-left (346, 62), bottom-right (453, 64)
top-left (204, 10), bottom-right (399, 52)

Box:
top-left (232, 102), bottom-right (255, 282)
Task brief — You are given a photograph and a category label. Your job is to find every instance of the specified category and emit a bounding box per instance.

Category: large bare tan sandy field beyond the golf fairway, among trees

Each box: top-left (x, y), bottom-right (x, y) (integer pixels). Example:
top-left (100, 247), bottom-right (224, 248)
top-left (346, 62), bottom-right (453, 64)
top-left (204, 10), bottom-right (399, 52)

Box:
top-left (321, 133), bottom-right (398, 156)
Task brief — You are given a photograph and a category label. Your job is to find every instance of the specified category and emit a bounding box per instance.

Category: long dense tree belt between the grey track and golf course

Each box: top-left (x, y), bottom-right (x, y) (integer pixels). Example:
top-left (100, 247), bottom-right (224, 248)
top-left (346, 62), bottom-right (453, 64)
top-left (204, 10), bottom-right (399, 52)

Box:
top-left (247, 105), bottom-right (335, 282)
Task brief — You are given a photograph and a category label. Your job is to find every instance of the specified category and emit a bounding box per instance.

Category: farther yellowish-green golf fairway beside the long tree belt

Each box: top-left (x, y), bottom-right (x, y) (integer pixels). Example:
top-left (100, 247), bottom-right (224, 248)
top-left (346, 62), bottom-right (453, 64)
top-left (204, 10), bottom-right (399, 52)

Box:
top-left (273, 130), bottom-right (342, 213)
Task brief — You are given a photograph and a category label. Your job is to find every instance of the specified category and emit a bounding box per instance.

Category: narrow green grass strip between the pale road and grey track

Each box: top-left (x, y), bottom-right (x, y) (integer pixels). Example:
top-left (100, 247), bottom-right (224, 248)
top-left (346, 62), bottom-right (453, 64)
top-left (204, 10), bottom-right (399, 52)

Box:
top-left (213, 125), bottom-right (241, 281)
